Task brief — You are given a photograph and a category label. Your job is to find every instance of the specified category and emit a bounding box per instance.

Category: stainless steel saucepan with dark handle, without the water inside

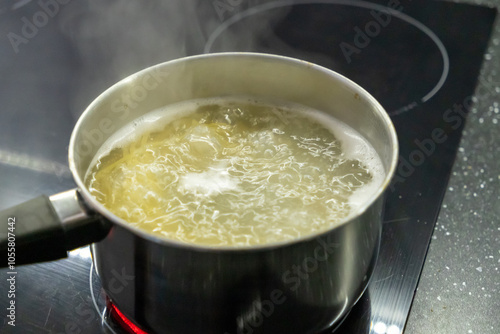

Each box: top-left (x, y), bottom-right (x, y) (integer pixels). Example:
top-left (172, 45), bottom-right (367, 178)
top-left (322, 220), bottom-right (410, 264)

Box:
top-left (0, 53), bottom-right (398, 334)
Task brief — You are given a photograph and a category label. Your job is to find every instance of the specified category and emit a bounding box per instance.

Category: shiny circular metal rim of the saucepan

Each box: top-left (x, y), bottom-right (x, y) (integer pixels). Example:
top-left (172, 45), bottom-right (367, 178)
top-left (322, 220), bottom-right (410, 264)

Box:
top-left (68, 52), bottom-right (399, 252)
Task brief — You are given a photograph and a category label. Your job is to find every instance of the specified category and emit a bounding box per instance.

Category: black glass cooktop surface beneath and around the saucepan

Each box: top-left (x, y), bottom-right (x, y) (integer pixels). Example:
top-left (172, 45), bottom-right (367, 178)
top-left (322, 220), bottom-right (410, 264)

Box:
top-left (0, 0), bottom-right (495, 334)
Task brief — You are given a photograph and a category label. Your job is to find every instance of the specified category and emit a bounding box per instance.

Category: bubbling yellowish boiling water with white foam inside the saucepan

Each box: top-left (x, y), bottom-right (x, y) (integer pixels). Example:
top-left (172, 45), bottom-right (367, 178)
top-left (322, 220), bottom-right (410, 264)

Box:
top-left (85, 98), bottom-right (384, 246)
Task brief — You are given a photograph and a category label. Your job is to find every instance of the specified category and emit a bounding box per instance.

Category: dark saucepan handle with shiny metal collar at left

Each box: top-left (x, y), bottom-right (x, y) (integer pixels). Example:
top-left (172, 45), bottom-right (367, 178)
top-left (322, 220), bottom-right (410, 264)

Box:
top-left (0, 188), bottom-right (110, 267)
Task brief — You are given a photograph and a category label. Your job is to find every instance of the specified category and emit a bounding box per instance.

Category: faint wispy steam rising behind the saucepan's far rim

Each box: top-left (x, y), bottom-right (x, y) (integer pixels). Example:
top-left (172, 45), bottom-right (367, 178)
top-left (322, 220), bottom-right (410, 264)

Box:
top-left (54, 0), bottom-right (288, 118)
